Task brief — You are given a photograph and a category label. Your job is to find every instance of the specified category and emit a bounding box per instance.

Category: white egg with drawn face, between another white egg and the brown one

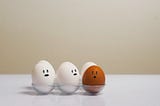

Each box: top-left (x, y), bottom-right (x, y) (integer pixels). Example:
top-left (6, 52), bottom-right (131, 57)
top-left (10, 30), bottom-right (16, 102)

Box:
top-left (56, 62), bottom-right (80, 94)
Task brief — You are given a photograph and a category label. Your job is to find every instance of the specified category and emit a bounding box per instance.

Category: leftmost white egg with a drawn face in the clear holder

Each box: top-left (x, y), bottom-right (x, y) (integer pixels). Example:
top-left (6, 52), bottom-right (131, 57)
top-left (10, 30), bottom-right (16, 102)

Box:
top-left (32, 60), bottom-right (56, 94)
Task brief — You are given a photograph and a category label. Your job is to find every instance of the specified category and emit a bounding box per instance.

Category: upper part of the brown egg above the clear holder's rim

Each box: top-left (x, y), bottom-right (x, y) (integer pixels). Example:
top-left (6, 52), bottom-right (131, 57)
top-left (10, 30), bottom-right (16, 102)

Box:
top-left (82, 66), bottom-right (105, 85)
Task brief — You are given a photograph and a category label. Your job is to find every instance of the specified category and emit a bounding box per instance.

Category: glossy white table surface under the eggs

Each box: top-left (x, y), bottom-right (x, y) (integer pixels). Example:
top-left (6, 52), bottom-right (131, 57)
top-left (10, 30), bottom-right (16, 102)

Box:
top-left (0, 75), bottom-right (160, 106)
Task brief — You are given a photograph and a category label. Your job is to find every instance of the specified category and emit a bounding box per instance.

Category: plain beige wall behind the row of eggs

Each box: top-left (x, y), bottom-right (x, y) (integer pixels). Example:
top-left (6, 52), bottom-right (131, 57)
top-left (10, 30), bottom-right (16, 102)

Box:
top-left (0, 0), bottom-right (160, 74)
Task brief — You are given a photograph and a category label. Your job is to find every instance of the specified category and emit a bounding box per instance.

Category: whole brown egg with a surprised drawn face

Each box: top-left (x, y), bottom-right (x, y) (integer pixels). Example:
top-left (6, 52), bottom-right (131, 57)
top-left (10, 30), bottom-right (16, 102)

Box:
top-left (82, 65), bottom-right (105, 94)
